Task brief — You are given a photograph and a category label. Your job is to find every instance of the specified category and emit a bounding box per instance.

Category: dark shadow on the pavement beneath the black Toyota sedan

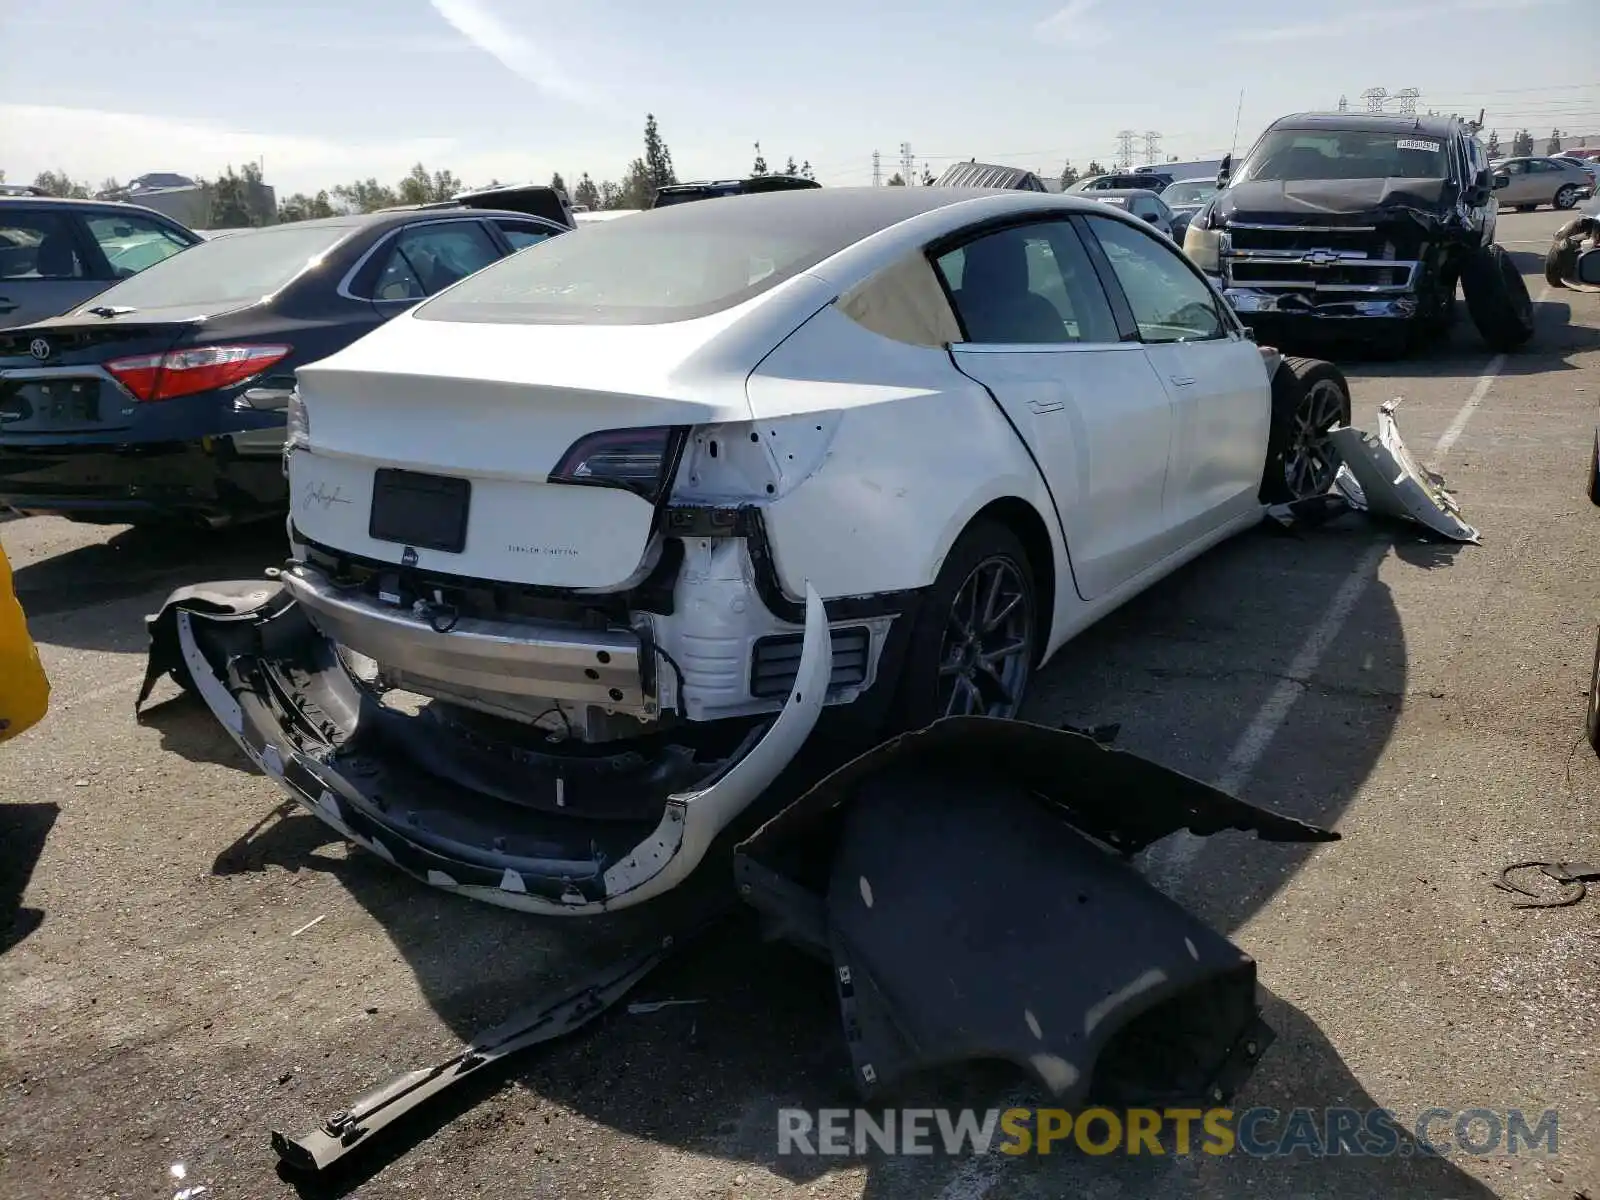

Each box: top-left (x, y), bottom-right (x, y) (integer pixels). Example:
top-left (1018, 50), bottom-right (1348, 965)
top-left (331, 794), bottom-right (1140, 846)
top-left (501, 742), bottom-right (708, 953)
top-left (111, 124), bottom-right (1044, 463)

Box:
top-left (13, 520), bottom-right (288, 650)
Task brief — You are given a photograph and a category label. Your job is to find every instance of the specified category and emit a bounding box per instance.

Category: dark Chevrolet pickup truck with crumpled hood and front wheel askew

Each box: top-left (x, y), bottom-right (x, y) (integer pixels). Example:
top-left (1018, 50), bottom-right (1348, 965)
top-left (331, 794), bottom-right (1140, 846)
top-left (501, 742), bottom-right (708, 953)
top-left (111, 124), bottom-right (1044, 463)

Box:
top-left (1184, 112), bottom-right (1533, 352)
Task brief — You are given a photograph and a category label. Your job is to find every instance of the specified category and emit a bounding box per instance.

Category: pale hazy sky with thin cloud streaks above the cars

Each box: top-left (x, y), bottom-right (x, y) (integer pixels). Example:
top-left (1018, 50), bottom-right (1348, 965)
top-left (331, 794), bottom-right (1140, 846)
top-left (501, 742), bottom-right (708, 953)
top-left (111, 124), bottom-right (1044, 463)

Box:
top-left (0, 0), bottom-right (1600, 197)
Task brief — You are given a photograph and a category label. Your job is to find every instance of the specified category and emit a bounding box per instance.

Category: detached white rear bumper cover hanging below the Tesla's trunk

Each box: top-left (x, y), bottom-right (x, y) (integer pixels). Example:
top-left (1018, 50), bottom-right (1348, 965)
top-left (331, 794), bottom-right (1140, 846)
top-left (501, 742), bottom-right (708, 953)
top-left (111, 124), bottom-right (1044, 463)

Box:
top-left (139, 581), bottom-right (832, 915)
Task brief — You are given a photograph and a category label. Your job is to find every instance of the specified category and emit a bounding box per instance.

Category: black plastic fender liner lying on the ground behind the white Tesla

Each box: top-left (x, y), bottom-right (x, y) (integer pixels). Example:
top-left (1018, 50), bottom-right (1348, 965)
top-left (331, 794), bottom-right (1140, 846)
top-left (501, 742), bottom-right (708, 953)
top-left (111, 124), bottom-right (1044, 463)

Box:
top-left (734, 717), bottom-right (1339, 1104)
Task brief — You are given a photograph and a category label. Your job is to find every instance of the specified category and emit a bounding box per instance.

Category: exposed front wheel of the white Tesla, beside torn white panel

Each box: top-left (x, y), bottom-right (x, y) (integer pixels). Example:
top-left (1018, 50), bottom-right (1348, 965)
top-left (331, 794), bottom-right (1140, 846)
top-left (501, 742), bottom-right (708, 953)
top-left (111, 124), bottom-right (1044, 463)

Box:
top-left (1261, 358), bottom-right (1350, 504)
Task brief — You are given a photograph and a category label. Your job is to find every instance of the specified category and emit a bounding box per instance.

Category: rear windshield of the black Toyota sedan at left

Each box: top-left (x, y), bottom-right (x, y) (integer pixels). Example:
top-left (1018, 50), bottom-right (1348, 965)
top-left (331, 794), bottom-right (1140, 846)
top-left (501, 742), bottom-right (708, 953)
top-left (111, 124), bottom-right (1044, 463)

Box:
top-left (68, 226), bottom-right (350, 309)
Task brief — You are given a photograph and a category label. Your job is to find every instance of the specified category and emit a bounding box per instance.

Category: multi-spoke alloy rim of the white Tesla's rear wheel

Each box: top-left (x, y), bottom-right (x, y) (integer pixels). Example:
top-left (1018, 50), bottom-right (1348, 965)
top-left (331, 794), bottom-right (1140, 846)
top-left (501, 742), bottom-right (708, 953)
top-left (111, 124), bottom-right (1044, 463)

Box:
top-left (939, 555), bottom-right (1034, 720)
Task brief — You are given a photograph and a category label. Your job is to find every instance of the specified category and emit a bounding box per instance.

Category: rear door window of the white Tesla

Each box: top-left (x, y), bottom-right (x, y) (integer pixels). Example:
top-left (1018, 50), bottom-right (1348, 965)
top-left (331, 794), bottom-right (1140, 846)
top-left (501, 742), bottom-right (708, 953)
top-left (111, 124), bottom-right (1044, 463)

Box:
top-left (936, 221), bottom-right (1117, 346)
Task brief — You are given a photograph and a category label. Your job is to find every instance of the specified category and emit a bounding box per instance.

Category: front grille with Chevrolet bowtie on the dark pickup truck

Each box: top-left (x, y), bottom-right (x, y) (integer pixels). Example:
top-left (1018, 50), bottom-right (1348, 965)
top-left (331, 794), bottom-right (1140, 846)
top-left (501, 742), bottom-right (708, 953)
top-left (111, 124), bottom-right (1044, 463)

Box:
top-left (1222, 222), bottom-right (1418, 294)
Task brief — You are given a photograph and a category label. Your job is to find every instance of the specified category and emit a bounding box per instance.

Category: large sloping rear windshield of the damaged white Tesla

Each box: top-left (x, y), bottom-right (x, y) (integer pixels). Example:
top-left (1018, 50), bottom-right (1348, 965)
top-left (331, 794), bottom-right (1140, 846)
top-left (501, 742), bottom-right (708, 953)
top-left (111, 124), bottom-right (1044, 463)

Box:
top-left (413, 203), bottom-right (844, 325)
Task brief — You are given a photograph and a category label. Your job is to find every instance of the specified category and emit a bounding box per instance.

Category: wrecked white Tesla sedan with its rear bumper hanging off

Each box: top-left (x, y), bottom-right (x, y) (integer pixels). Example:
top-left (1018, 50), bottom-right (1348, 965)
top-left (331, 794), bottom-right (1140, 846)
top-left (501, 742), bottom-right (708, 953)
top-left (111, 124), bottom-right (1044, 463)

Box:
top-left (152, 187), bottom-right (1349, 912)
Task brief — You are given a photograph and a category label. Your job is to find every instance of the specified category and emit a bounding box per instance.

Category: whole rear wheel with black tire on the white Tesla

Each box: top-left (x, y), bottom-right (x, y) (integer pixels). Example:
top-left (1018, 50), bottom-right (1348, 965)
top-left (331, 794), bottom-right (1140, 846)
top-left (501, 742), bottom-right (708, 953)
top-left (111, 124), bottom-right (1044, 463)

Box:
top-left (888, 518), bottom-right (1043, 734)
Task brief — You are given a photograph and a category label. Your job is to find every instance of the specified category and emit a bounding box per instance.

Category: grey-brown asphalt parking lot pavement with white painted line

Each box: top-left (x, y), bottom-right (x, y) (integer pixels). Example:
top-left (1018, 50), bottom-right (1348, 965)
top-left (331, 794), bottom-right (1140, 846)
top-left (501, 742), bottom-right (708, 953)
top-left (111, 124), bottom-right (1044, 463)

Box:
top-left (0, 213), bottom-right (1600, 1200)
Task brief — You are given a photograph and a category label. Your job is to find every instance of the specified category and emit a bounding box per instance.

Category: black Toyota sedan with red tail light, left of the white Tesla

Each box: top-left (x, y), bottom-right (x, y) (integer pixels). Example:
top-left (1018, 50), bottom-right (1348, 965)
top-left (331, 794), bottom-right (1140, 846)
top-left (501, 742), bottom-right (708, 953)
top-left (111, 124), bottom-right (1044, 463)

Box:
top-left (0, 203), bottom-right (568, 528)
